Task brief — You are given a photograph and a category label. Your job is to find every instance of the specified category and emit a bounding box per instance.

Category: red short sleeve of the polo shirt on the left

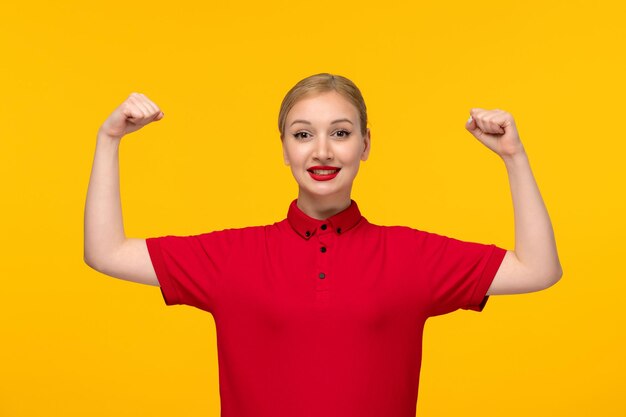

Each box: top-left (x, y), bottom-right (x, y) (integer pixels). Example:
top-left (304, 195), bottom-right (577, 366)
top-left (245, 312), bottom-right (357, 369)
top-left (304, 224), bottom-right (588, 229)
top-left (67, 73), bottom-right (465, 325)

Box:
top-left (146, 229), bottom-right (235, 312)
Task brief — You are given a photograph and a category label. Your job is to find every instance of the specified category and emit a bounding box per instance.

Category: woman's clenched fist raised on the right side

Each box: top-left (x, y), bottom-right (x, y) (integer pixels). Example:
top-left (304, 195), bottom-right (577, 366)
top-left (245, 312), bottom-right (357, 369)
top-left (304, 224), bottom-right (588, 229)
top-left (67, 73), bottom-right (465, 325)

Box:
top-left (465, 108), bottom-right (524, 158)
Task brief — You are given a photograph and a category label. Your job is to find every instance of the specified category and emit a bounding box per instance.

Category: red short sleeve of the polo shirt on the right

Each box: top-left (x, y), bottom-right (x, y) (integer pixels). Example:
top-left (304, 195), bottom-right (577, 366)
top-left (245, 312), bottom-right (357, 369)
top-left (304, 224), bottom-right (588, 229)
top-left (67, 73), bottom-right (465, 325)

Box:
top-left (416, 230), bottom-right (506, 316)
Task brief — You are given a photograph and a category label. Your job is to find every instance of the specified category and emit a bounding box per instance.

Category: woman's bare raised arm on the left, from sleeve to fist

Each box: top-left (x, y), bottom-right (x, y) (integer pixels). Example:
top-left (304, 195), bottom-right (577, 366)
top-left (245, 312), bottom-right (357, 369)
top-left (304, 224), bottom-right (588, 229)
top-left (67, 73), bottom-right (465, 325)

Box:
top-left (83, 93), bottom-right (163, 286)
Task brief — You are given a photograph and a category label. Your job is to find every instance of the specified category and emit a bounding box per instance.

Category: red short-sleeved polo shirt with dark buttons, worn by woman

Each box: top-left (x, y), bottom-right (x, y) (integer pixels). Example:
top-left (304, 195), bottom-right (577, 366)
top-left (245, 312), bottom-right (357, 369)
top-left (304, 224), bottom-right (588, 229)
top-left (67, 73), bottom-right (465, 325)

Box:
top-left (146, 200), bottom-right (506, 417)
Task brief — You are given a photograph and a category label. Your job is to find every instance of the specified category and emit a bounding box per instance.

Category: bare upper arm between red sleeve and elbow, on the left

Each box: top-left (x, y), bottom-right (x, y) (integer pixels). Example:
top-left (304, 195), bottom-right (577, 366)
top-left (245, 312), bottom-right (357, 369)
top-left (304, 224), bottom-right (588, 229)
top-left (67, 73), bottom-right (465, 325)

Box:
top-left (89, 238), bottom-right (159, 286)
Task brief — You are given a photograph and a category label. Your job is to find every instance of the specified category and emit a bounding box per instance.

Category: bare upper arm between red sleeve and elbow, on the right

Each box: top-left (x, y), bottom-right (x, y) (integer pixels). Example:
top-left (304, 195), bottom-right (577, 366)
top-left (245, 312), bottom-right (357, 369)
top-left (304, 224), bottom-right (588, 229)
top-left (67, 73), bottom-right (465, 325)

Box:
top-left (487, 250), bottom-right (545, 295)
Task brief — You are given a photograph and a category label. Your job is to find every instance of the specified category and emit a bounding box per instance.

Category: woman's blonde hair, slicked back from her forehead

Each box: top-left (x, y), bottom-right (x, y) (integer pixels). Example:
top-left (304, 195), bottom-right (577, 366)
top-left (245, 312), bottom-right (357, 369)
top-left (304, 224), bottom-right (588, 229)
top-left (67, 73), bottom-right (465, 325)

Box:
top-left (278, 72), bottom-right (367, 140)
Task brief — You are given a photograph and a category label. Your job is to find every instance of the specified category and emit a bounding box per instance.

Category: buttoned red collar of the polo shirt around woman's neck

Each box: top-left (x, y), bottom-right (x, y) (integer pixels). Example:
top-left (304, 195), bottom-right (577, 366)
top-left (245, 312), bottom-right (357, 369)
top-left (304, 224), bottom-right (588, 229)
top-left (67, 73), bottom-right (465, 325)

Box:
top-left (287, 199), bottom-right (363, 239)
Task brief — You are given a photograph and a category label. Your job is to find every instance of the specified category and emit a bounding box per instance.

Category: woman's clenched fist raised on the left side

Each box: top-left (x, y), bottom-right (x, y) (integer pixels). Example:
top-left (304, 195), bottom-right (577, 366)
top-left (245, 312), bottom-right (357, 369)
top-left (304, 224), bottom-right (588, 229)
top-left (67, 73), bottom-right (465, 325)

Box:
top-left (99, 93), bottom-right (164, 139)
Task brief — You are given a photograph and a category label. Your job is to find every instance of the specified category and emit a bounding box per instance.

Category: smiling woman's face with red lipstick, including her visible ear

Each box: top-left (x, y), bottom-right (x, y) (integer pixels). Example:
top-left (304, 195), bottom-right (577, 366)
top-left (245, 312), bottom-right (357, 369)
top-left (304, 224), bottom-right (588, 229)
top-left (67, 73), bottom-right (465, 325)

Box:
top-left (283, 91), bottom-right (370, 202)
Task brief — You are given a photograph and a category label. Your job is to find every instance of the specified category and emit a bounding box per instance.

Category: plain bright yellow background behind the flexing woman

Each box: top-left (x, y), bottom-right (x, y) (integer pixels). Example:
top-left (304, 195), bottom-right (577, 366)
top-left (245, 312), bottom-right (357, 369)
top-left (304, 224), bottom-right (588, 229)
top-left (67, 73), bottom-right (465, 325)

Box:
top-left (0, 0), bottom-right (626, 417)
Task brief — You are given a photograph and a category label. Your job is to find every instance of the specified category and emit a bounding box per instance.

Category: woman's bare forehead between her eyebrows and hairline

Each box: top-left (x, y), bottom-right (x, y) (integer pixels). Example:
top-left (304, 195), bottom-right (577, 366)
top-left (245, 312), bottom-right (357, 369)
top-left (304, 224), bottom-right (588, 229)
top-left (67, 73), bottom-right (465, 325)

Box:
top-left (287, 91), bottom-right (358, 122)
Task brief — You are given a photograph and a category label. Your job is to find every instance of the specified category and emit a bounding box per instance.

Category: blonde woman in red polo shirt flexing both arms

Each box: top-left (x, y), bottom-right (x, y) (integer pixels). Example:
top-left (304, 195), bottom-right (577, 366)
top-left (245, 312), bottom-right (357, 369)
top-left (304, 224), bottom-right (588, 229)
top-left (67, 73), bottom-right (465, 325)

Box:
top-left (85, 73), bottom-right (562, 417)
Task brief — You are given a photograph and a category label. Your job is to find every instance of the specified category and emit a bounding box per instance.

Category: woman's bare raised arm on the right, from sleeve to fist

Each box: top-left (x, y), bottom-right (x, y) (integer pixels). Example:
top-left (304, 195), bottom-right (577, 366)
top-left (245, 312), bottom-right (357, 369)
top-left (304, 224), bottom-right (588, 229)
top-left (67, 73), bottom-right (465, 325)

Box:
top-left (465, 108), bottom-right (563, 295)
